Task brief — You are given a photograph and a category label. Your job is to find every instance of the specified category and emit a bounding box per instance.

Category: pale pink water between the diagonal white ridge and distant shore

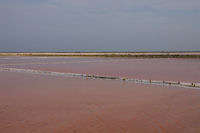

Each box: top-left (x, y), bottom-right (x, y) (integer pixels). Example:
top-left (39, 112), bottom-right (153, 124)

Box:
top-left (0, 57), bottom-right (200, 83)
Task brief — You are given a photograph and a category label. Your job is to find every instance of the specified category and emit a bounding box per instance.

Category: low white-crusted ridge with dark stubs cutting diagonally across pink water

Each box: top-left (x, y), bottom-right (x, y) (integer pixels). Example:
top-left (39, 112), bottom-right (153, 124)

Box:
top-left (0, 67), bottom-right (200, 89)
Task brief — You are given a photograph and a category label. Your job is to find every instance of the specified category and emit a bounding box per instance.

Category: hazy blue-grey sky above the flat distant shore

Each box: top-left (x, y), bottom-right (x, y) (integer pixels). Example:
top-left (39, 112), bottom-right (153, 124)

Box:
top-left (0, 0), bottom-right (200, 52)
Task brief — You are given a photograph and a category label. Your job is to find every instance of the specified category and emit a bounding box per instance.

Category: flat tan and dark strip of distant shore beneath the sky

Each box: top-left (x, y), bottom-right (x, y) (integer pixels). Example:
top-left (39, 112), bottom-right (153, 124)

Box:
top-left (0, 52), bottom-right (200, 58)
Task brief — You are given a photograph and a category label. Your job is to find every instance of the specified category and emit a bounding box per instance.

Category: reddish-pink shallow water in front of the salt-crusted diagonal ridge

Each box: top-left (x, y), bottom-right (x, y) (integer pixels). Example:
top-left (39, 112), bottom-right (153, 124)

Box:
top-left (0, 72), bottom-right (200, 133)
